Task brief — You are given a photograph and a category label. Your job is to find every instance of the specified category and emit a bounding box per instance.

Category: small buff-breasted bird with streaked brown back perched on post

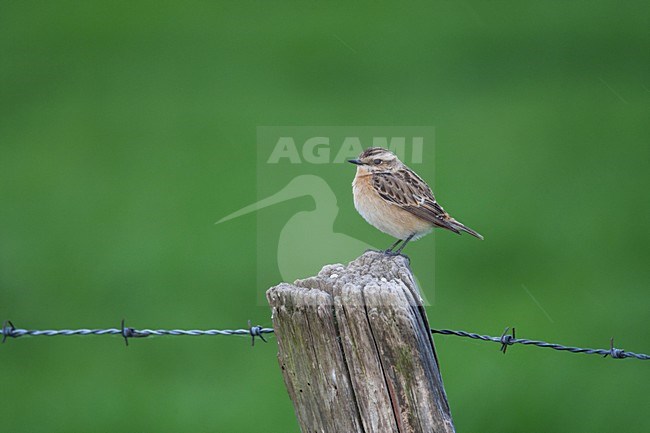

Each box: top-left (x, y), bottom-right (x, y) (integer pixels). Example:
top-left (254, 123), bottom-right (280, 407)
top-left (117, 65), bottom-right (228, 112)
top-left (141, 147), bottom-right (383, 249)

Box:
top-left (348, 147), bottom-right (483, 255)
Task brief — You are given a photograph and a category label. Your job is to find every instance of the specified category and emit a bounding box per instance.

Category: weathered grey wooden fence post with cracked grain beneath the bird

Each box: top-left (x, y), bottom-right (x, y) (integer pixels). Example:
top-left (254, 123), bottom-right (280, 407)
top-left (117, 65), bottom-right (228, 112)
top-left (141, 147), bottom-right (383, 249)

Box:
top-left (266, 251), bottom-right (454, 433)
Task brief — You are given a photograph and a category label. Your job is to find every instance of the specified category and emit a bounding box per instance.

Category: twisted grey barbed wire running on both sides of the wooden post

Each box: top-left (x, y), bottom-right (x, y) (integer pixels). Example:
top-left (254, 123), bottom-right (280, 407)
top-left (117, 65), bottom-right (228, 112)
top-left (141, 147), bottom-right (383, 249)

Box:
top-left (2, 320), bottom-right (650, 360)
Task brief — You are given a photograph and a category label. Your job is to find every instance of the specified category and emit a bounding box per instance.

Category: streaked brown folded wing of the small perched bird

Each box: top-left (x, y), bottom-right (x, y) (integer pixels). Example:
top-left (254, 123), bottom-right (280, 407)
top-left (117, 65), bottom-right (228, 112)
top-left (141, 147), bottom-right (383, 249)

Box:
top-left (372, 169), bottom-right (460, 233)
